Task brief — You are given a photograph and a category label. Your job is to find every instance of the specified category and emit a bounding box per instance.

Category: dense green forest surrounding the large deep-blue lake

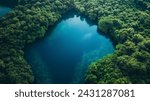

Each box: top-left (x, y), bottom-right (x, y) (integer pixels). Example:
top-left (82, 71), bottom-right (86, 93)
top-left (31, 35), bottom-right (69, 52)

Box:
top-left (0, 0), bottom-right (150, 84)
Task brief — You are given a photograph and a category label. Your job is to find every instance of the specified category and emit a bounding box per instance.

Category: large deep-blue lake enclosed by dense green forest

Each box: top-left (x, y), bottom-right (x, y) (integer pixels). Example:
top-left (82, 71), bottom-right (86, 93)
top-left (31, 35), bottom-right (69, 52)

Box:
top-left (25, 14), bottom-right (114, 84)
